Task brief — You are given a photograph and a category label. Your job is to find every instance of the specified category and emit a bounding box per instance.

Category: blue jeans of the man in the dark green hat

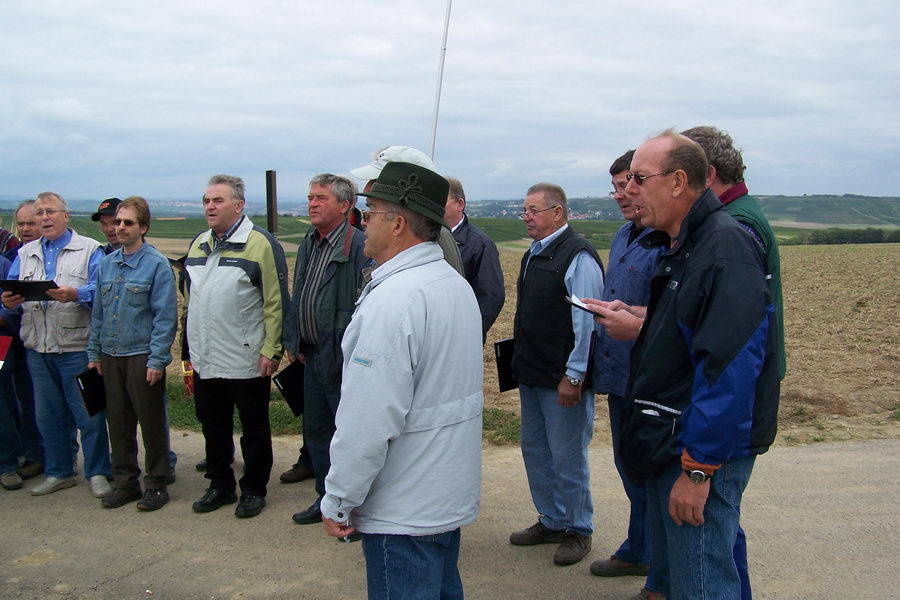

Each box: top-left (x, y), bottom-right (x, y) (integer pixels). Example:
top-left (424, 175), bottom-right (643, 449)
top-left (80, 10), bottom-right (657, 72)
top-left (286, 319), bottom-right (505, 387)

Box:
top-left (362, 528), bottom-right (463, 600)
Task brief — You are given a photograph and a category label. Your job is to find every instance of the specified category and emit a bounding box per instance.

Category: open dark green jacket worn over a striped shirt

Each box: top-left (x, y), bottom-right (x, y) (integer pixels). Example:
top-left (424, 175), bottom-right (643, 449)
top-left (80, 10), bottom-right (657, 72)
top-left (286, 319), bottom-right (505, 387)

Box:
top-left (285, 226), bottom-right (369, 386)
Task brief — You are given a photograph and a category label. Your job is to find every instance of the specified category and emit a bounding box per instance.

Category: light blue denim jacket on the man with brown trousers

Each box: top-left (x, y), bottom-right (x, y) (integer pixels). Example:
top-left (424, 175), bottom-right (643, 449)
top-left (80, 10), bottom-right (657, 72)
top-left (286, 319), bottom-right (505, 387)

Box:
top-left (87, 243), bottom-right (178, 370)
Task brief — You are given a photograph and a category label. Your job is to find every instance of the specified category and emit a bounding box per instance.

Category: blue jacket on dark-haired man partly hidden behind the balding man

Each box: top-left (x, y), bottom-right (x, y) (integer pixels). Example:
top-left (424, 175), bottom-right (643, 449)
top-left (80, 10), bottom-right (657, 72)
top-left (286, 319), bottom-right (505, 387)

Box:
top-left (594, 221), bottom-right (662, 396)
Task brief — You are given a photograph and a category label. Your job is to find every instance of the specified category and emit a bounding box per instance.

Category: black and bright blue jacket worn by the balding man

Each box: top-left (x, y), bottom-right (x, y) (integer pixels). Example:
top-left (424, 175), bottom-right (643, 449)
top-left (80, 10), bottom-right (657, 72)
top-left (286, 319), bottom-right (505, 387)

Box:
top-left (620, 190), bottom-right (779, 478)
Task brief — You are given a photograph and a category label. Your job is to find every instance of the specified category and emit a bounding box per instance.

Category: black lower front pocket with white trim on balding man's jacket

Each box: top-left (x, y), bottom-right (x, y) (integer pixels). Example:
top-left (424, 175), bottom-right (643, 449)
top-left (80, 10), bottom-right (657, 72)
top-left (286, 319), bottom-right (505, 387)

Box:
top-left (619, 398), bottom-right (681, 480)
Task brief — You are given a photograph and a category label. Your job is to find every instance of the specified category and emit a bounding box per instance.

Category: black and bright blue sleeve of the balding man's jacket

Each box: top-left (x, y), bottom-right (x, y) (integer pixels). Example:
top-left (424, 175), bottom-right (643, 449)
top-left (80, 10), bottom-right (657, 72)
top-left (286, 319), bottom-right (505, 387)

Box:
top-left (678, 259), bottom-right (773, 465)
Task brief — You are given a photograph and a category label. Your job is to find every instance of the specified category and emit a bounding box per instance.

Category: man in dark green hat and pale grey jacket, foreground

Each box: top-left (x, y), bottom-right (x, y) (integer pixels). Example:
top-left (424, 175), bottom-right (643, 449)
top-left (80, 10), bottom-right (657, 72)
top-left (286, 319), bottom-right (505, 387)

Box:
top-left (321, 162), bottom-right (484, 600)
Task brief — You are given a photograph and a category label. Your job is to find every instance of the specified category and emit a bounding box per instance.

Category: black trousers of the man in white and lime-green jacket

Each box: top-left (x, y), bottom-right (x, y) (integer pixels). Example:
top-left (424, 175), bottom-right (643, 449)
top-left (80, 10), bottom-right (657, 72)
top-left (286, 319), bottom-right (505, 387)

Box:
top-left (194, 371), bottom-right (272, 496)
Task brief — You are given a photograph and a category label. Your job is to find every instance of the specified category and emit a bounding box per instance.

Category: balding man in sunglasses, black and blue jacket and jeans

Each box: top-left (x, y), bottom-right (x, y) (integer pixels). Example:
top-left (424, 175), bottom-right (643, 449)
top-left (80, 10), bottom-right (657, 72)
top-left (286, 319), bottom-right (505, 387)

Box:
top-left (588, 130), bottom-right (779, 600)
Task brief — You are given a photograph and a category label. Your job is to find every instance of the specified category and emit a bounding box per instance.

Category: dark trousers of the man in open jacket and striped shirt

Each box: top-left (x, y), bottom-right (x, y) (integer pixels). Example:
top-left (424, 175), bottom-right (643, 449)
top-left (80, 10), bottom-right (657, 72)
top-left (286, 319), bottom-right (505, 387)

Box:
top-left (303, 350), bottom-right (341, 498)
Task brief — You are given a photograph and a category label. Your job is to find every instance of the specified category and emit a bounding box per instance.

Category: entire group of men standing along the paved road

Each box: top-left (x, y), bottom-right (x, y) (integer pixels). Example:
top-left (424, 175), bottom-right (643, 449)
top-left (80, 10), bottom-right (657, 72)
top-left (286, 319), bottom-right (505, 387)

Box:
top-left (0, 127), bottom-right (785, 599)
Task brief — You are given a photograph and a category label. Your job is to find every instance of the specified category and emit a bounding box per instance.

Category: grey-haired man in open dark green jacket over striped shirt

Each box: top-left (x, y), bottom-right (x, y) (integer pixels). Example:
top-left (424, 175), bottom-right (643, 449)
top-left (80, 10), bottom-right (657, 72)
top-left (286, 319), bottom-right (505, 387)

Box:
top-left (281, 173), bottom-right (368, 525)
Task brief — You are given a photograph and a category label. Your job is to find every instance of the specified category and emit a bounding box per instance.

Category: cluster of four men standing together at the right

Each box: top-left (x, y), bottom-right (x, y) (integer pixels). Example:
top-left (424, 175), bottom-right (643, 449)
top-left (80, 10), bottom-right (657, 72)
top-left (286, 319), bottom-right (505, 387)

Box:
top-left (510, 127), bottom-right (785, 600)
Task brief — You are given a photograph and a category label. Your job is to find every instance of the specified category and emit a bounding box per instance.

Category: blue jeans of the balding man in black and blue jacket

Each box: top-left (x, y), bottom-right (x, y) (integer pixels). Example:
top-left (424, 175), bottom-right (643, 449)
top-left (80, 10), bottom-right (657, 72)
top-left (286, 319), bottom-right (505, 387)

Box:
top-left (647, 456), bottom-right (756, 600)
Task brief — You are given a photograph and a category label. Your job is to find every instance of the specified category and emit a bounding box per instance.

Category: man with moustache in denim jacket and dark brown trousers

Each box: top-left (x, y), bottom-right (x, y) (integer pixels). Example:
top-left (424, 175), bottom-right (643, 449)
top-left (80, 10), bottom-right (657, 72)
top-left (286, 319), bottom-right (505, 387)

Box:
top-left (88, 196), bottom-right (178, 511)
